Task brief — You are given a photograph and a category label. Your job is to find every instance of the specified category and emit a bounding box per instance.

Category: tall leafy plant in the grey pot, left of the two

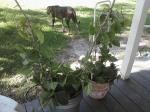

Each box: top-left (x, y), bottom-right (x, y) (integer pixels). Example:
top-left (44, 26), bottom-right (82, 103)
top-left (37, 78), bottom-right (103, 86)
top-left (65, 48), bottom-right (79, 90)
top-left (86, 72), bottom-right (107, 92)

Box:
top-left (15, 0), bottom-right (82, 112)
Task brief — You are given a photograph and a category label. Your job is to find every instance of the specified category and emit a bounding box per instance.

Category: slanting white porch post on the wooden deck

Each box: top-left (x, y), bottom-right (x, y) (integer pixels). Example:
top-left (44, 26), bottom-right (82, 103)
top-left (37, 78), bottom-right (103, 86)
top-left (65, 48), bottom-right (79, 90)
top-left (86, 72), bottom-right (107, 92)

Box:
top-left (121, 0), bottom-right (150, 79)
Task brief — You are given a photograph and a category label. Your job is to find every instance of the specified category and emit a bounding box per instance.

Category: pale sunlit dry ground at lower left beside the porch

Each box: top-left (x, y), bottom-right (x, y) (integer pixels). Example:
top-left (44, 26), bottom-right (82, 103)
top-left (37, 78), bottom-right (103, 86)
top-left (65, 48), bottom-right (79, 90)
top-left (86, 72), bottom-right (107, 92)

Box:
top-left (0, 74), bottom-right (39, 103)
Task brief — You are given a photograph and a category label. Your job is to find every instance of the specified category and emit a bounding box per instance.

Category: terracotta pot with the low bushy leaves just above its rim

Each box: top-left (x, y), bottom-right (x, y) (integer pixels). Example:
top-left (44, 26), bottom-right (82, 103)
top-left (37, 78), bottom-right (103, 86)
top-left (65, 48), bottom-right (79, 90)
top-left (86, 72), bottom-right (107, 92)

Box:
top-left (84, 58), bottom-right (119, 99)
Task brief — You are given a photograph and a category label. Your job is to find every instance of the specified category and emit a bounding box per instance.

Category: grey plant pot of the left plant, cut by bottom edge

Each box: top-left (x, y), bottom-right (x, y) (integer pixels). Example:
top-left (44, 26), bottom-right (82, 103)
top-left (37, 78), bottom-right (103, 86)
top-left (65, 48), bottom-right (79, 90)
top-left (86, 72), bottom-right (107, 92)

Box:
top-left (52, 92), bottom-right (83, 112)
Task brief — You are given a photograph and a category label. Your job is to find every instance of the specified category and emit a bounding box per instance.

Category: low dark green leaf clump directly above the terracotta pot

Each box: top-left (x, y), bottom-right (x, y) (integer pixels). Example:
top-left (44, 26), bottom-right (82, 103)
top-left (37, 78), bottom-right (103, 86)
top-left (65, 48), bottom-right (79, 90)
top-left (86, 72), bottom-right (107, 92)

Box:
top-left (84, 61), bottom-right (118, 83)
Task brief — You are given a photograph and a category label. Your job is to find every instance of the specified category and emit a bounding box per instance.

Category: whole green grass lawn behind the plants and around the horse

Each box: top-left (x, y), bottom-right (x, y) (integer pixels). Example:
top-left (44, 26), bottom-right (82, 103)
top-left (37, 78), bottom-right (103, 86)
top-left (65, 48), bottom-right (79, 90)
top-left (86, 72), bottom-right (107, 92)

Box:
top-left (0, 0), bottom-right (150, 102)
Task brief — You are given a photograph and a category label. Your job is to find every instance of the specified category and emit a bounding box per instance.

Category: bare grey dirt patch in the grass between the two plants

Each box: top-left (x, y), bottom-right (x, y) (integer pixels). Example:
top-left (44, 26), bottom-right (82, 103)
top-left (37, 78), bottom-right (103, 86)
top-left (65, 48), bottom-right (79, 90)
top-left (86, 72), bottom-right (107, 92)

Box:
top-left (56, 37), bottom-right (89, 63)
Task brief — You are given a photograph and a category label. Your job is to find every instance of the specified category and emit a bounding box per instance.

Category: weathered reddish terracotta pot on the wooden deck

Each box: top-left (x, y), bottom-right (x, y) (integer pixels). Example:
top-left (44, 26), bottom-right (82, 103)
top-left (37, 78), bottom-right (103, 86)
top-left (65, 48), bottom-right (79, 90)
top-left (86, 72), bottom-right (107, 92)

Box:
top-left (89, 81), bottom-right (110, 99)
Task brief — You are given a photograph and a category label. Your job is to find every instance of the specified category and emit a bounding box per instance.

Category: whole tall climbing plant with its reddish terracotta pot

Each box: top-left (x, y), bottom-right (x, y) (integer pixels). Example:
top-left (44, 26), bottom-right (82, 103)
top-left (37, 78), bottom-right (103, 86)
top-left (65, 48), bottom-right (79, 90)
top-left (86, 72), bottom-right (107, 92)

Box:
top-left (82, 0), bottom-right (124, 99)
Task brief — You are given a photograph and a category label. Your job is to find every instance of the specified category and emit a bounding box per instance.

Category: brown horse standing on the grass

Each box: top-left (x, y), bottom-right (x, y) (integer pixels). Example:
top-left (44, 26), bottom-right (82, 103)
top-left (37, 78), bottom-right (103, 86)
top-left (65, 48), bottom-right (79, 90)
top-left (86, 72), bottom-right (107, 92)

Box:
top-left (47, 5), bottom-right (80, 32)
